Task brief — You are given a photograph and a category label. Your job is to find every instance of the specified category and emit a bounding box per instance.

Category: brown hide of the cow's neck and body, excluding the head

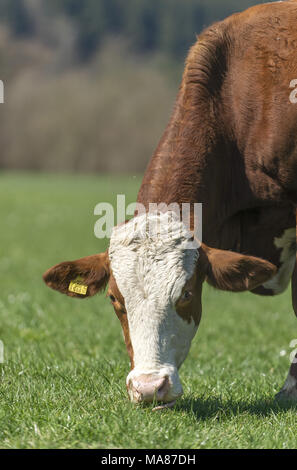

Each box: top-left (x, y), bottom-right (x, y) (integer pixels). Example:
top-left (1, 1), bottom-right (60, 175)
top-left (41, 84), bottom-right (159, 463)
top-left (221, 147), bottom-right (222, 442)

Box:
top-left (138, 2), bottom-right (297, 282)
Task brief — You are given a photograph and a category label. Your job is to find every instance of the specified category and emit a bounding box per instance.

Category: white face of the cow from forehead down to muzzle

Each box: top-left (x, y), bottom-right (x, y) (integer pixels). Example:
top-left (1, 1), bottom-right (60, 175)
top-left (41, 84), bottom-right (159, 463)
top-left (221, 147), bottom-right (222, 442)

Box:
top-left (109, 213), bottom-right (200, 402)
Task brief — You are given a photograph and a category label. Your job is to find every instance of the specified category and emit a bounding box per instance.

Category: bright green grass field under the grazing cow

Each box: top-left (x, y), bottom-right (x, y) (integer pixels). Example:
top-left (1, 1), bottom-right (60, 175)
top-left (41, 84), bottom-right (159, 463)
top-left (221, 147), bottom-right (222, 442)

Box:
top-left (0, 173), bottom-right (297, 449)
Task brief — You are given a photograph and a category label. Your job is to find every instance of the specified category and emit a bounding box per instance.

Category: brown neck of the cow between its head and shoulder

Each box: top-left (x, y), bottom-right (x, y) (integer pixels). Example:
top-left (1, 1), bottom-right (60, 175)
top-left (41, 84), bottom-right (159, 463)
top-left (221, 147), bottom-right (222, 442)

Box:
top-left (138, 23), bottom-right (295, 262)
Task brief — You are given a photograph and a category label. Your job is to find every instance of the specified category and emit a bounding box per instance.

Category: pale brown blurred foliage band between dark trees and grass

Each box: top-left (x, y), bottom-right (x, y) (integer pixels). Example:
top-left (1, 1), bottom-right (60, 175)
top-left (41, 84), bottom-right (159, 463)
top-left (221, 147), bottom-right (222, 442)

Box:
top-left (0, 35), bottom-right (176, 174)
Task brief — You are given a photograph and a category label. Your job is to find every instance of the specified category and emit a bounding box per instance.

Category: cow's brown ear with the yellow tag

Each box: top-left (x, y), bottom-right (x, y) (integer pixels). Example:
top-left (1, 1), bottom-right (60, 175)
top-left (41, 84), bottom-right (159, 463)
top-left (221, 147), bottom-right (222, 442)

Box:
top-left (43, 252), bottom-right (109, 299)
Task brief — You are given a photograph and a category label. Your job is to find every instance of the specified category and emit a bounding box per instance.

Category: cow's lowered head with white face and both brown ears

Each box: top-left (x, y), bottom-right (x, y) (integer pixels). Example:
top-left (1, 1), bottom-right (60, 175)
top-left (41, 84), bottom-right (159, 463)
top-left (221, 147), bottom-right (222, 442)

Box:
top-left (44, 213), bottom-right (276, 403)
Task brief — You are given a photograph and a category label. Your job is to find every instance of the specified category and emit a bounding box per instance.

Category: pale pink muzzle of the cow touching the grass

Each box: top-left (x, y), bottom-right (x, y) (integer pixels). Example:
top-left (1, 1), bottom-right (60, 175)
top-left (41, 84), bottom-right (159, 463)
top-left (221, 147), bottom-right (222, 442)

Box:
top-left (129, 375), bottom-right (170, 402)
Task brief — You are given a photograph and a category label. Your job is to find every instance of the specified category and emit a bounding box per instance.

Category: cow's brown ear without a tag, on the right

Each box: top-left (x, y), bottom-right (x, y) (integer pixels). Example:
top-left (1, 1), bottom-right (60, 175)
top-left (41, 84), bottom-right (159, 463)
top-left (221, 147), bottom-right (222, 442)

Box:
top-left (198, 243), bottom-right (277, 292)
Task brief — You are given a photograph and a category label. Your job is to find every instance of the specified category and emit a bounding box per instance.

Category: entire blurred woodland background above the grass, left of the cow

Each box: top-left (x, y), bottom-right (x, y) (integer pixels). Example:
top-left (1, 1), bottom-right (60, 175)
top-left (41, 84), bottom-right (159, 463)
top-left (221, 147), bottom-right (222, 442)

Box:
top-left (0, 0), bottom-right (268, 174)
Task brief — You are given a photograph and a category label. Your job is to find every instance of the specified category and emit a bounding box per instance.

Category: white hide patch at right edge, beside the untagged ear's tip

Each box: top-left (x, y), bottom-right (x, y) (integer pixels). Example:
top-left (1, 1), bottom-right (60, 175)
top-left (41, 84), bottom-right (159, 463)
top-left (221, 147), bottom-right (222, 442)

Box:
top-left (263, 228), bottom-right (296, 294)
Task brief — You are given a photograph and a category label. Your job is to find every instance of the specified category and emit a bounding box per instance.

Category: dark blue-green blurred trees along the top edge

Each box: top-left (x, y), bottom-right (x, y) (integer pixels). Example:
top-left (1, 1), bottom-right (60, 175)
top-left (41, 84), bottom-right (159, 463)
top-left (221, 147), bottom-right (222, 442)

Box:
top-left (0, 0), bottom-right (264, 60)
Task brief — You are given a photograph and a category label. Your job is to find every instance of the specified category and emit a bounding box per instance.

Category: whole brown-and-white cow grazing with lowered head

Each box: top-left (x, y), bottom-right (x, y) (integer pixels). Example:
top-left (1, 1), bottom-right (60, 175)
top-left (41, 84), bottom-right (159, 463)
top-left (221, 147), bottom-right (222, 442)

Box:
top-left (44, 1), bottom-right (297, 406)
